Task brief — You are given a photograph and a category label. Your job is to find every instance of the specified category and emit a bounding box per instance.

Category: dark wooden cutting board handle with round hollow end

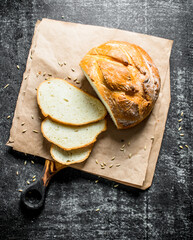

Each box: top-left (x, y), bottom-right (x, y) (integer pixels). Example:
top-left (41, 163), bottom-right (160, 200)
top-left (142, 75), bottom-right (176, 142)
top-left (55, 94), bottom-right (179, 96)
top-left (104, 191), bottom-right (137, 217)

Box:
top-left (20, 160), bottom-right (65, 210)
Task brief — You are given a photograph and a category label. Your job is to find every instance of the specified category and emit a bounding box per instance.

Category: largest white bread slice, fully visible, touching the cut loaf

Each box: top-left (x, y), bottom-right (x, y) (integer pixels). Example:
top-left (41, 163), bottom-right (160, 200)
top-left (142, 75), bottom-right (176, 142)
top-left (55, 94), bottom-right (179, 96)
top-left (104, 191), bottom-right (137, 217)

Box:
top-left (37, 78), bottom-right (107, 126)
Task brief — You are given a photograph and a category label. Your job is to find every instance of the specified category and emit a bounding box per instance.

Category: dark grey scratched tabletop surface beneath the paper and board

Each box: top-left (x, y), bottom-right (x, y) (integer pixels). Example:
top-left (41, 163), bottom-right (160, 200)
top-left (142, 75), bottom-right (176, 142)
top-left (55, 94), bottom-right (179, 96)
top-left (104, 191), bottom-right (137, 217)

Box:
top-left (0, 0), bottom-right (193, 240)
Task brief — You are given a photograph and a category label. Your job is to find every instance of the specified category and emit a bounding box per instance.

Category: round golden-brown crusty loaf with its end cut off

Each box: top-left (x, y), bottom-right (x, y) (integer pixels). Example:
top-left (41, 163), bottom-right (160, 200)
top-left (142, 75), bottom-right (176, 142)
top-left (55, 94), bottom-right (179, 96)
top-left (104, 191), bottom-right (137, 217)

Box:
top-left (80, 41), bottom-right (161, 129)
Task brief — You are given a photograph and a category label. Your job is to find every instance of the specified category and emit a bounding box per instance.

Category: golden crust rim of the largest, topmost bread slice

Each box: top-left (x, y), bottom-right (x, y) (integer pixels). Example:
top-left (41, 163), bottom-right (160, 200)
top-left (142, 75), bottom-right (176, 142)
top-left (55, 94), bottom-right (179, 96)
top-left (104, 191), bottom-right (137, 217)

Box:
top-left (37, 78), bottom-right (107, 126)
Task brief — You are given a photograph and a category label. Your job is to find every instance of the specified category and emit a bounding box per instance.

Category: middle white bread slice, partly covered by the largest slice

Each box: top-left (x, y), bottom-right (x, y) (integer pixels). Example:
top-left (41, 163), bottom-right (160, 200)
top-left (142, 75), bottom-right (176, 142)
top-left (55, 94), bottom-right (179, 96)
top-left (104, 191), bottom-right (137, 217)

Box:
top-left (41, 118), bottom-right (107, 150)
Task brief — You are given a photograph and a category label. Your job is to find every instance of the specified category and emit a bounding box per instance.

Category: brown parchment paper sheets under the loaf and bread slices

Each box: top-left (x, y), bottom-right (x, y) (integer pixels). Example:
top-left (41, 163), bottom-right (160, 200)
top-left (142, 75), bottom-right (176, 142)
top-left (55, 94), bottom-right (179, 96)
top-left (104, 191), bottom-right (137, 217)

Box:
top-left (7, 19), bottom-right (173, 189)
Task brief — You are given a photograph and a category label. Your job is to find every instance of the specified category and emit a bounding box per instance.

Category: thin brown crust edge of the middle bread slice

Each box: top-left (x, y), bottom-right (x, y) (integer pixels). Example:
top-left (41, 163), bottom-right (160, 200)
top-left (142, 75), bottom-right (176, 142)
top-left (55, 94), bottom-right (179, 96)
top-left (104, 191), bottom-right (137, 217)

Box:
top-left (41, 118), bottom-right (107, 151)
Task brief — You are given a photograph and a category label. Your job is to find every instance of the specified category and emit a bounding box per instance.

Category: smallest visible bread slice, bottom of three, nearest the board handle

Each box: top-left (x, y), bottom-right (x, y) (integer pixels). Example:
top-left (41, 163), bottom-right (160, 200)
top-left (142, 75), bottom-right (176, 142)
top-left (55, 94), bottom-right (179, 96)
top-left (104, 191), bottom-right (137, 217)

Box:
top-left (50, 144), bottom-right (92, 165)
